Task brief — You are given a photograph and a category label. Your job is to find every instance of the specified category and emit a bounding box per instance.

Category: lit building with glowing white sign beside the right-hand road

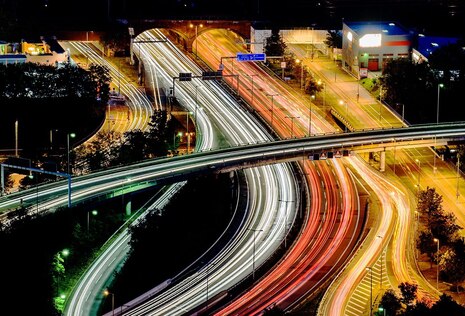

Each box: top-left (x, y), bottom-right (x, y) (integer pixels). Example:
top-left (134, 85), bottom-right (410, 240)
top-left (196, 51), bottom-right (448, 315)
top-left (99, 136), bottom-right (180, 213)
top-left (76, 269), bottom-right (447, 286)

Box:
top-left (342, 22), bottom-right (411, 78)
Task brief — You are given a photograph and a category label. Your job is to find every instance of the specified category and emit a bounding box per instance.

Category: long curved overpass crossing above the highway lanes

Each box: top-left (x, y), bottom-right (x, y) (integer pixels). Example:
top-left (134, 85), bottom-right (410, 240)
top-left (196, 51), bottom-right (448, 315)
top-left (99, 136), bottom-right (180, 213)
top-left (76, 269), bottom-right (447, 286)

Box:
top-left (0, 122), bottom-right (465, 213)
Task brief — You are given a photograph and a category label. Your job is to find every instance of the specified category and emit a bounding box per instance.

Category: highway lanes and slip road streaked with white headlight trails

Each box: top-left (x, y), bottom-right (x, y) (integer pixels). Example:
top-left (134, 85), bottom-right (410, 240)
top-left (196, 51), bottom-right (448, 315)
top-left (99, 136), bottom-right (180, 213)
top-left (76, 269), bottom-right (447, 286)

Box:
top-left (61, 31), bottom-right (297, 315)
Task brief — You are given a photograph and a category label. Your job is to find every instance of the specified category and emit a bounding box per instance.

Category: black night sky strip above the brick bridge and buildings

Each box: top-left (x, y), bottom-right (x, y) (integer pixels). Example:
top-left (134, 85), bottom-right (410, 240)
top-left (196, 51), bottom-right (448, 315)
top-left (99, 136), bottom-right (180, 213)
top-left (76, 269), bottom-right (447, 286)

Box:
top-left (0, 0), bottom-right (465, 33)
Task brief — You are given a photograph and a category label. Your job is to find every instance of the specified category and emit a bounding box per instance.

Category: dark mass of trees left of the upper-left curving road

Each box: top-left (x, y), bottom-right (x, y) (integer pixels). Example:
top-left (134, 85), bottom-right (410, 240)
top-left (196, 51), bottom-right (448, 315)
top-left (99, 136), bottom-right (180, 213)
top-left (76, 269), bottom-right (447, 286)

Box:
top-left (0, 63), bottom-right (110, 150)
